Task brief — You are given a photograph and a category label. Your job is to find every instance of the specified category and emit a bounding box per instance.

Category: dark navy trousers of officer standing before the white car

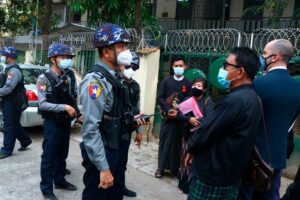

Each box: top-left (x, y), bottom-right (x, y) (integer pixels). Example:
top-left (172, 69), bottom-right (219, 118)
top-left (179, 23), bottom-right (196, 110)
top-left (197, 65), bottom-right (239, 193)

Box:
top-left (40, 119), bottom-right (71, 194)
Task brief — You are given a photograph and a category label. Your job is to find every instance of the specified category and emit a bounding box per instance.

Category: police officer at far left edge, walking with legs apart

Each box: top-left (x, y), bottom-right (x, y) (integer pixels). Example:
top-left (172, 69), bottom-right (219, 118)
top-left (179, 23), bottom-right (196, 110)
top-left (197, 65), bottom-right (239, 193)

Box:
top-left (0, 47), bottom-right (32, 159)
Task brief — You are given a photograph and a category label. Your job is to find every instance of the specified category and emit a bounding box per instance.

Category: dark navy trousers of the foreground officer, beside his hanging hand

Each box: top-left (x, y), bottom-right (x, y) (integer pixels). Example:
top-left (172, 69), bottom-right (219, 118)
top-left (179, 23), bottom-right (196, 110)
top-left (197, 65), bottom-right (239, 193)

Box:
top-left (80, 142), bottom-right (123, 200)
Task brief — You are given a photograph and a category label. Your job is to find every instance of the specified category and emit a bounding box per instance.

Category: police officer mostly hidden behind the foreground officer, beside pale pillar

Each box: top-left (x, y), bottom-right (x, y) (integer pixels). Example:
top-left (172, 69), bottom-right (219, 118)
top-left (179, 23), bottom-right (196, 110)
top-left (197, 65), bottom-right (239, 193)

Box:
top-left (118, 51), bottom-right (142, 197)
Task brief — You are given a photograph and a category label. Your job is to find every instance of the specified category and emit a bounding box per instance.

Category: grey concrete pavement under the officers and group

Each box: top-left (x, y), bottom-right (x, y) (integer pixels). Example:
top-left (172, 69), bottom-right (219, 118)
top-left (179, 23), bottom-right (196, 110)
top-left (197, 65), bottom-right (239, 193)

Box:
top-left (0, 128), bottom-right (291, 200)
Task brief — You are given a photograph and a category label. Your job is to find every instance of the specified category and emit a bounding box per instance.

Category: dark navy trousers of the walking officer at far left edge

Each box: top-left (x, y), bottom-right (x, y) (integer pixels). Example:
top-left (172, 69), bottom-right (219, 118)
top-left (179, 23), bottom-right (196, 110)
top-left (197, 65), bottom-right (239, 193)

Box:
top-left (1, 99), bottom-right (31, 155)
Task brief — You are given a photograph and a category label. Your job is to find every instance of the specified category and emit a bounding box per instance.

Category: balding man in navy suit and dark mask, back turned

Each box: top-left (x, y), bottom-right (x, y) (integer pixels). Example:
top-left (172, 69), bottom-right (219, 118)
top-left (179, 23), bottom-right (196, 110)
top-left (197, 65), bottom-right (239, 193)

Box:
top-left (240, 39), bottom-right (300, 200)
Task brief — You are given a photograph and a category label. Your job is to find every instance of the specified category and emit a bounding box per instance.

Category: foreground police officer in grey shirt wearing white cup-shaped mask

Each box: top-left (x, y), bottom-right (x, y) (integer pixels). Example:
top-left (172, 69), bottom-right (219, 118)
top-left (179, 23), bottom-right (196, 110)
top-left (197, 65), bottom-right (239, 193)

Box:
top-left (79, 24), bottom-right (145, 200)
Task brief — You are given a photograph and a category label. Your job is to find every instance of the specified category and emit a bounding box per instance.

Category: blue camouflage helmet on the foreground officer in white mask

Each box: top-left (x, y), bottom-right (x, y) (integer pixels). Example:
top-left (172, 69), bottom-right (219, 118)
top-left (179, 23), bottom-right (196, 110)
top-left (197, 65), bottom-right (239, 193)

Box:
top-left (94, 23), bottom-right (130, 48)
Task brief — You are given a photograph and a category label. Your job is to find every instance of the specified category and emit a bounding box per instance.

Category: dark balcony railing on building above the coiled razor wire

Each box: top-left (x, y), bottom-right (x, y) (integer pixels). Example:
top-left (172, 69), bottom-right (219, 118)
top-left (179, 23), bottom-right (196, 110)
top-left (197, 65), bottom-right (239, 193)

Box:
top-left (158, 18), bottom-right (300, 33)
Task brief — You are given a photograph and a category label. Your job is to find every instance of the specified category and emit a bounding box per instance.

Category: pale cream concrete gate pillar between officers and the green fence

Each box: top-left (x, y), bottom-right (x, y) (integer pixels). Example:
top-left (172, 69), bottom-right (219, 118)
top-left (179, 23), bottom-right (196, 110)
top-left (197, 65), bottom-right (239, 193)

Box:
top-left (134, 50), bottom-right (160, 120)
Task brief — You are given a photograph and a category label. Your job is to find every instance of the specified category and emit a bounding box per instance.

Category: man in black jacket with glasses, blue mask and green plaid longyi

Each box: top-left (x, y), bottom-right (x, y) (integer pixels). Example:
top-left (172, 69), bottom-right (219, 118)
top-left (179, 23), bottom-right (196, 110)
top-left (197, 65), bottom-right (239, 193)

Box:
top-left (185, 47), bottom-right (262, 200)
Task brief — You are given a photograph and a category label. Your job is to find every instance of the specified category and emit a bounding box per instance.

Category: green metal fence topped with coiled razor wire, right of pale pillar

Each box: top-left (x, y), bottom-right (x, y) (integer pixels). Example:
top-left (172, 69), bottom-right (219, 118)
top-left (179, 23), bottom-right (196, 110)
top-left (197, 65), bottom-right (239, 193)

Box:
top-left (154, 28), bottom-right (300, 133)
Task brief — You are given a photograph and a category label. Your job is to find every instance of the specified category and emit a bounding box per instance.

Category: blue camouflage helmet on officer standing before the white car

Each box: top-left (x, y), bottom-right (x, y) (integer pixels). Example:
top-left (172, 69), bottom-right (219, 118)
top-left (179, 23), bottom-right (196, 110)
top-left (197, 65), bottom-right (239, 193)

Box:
top-left (48, 43), bottom-right (75, 58)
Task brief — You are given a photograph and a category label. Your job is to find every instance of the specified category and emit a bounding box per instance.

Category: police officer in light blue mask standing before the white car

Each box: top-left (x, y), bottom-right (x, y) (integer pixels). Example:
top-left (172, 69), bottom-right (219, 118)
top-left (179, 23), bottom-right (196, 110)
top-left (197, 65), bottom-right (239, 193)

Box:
top-left (37, 43), bottom-right (82, 200)
